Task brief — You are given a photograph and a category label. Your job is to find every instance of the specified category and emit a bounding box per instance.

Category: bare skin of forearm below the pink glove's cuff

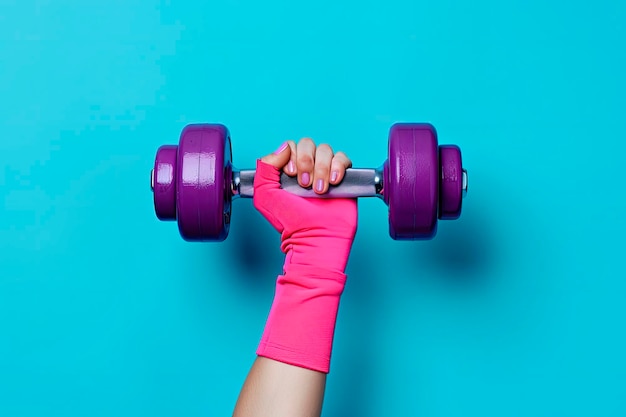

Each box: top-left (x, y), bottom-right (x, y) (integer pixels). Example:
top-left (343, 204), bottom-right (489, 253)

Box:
top-left (233, 357), bottom-right (326, 417)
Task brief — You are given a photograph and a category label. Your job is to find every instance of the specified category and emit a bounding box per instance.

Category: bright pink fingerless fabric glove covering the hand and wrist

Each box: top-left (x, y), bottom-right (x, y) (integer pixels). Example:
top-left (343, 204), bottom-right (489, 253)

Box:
top-left (254, 160), bottom-right (357, 373)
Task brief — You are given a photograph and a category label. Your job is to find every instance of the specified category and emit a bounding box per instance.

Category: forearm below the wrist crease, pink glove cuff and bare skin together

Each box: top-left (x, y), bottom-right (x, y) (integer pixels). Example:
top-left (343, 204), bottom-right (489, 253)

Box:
top-left (234, 268), bottom-right (343, 417)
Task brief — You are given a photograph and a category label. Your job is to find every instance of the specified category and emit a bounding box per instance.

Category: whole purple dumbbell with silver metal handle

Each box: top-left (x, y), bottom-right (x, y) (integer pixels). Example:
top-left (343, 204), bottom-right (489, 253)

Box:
top-left (150, 123), bottom-right (468, 242)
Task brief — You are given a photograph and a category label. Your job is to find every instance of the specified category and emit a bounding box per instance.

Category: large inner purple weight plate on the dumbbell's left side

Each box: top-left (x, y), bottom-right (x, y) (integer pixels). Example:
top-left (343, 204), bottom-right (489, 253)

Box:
top-left (176, 124), bottom-right (231, 242)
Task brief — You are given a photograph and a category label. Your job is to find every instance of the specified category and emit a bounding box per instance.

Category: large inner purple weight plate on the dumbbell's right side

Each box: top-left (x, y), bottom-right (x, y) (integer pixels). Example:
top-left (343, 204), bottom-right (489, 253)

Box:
top-left (384, 123), bottom-right (439, 240)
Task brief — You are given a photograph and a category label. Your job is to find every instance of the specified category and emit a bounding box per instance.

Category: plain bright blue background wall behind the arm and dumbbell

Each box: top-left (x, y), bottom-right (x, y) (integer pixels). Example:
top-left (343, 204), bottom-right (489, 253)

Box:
top-left (0, 0), bottom-right (626, 417)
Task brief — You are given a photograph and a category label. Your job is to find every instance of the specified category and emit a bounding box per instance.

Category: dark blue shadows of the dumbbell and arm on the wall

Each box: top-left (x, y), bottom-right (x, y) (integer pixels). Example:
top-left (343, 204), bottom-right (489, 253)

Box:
top-left (195, 200), bottom-right (497, 417)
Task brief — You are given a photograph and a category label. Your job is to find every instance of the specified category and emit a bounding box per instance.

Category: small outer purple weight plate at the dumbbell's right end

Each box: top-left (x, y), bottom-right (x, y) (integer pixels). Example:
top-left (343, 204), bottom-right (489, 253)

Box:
top-left (439, 145), bottom-right (463, 220)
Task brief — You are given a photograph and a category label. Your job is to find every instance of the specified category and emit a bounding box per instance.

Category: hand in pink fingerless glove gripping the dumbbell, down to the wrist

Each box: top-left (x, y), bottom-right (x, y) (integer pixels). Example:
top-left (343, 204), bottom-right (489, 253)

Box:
top-left (254, 139), bottom-right (357, 273)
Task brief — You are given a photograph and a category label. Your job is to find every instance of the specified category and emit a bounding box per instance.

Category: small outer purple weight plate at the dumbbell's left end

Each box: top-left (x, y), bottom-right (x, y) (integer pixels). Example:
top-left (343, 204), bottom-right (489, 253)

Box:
top-left (151, 145), bottom-right (178, 220)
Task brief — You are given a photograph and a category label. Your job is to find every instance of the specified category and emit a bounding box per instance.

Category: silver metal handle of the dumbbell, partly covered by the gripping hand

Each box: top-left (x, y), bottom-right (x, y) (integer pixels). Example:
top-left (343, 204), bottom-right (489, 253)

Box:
top-left (232, 167), bottom-right (383, 198)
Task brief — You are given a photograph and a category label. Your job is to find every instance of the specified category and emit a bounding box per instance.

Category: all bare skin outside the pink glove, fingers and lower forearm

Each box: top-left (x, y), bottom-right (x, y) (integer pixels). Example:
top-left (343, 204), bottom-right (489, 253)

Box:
top-left (233, 138), bottom-right (352, 417)
